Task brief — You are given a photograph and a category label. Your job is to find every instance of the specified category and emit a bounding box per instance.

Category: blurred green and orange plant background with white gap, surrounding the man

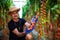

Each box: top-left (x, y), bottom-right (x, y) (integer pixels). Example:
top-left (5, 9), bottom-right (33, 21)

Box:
top-left (0, 0), bottom-right (60, 40)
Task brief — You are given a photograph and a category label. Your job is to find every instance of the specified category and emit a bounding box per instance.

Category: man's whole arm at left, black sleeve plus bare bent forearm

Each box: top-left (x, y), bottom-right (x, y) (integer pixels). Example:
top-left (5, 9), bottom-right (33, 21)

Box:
top-left (8, 21), bottom-right (25, 37)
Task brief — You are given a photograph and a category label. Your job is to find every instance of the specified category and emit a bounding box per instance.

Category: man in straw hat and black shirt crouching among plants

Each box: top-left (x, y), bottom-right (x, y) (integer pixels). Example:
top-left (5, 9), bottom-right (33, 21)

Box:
top-left (8, 6), bottom-right (32, 40)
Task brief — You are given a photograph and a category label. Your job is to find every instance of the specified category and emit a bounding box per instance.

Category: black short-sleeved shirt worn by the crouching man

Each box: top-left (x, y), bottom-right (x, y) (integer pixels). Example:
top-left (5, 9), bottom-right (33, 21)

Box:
top-left (8, 18), bottom-right (26, 40)
